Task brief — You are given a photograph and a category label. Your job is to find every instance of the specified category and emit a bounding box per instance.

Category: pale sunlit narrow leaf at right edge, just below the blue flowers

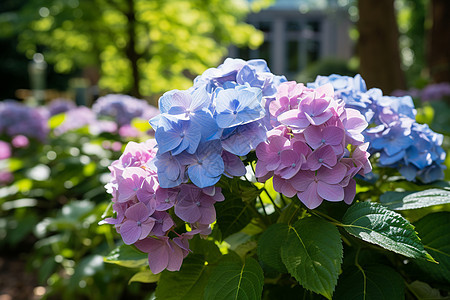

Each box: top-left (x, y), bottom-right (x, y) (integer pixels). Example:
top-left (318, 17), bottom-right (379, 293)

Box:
top-left (380, 189), bottom-right (450, 210)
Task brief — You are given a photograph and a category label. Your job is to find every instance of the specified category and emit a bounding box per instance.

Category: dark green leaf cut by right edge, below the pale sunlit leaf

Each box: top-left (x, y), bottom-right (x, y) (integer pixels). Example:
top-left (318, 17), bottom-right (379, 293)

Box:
top-left (413, 212), bottom-right (450, 284)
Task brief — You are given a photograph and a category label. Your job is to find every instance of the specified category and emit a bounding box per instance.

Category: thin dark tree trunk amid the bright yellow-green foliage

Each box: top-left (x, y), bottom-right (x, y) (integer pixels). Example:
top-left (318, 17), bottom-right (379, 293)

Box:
top-left (125, 0), bottom-right (142, 98)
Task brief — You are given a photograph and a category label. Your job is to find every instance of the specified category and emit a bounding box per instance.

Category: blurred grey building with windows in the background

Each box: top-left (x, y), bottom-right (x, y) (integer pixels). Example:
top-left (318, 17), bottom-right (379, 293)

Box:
top-left (230, 0), bottom-right (354, 79)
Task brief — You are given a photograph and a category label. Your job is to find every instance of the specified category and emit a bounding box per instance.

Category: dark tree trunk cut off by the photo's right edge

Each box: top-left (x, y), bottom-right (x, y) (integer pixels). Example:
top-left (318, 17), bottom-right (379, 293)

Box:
top-left (428, 0), bottom-right (450, 82)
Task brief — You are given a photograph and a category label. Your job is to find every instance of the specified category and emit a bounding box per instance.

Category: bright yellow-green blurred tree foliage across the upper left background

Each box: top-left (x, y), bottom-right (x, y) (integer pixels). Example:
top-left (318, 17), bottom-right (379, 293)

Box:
top-left (0, 0), bottom-right (267, 95)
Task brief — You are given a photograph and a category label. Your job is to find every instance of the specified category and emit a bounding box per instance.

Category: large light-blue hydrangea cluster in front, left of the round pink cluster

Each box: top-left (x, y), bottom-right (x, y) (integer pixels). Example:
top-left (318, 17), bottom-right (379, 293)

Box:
top-left (150, 58), bottom-right (285, 188)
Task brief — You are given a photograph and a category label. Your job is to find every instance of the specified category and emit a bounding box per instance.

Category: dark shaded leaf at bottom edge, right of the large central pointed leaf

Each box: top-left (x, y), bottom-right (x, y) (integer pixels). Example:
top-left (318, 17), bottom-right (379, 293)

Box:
top-left (333, 265), bottom-right (405, 300)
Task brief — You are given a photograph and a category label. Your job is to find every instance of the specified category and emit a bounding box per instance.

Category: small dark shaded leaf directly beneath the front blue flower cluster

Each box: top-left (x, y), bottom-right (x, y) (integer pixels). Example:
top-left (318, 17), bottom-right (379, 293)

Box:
top-left (214, 191), bottom-right (252, 239)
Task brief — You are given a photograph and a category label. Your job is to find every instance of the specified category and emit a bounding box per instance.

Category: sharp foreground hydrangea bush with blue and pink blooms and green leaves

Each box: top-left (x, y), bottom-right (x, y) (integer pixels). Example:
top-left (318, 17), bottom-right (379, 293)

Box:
top-left (102, 58), bottom-right (450, 299)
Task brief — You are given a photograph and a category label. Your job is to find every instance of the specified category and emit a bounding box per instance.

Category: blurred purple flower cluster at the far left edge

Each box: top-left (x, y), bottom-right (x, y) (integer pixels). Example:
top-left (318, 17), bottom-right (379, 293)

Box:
top-left (0, 100), bottom-right (49, 141)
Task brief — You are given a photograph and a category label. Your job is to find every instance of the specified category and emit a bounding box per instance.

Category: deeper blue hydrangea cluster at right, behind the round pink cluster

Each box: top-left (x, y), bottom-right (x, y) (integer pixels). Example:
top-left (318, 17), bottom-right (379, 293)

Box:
top-left (308, 74), bottom-right (445, 183)
